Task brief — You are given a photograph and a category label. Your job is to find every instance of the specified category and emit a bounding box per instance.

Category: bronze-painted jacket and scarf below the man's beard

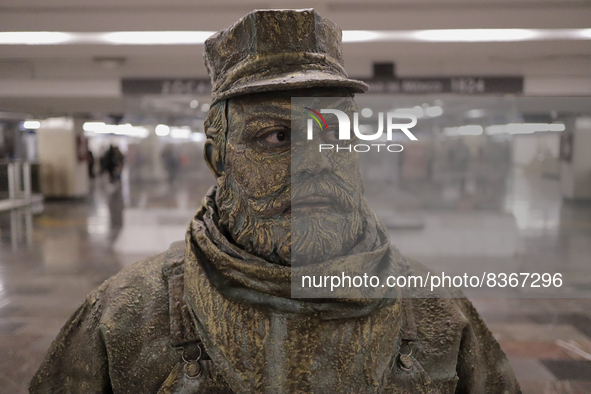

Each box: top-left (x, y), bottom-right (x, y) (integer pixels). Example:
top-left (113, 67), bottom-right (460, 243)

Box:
top-left (31, 189), bottom-right (519, 394)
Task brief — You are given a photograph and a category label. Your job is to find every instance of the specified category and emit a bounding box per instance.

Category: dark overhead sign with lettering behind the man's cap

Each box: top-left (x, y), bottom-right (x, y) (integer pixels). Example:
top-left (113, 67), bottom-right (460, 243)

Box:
top-left (121, 76), bottom-right (523, 95)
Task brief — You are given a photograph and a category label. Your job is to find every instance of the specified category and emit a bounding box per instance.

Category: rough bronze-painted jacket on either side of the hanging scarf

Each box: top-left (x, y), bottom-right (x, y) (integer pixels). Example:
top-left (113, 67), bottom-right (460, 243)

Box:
top-left (30, 245), bottom-right (519, 394)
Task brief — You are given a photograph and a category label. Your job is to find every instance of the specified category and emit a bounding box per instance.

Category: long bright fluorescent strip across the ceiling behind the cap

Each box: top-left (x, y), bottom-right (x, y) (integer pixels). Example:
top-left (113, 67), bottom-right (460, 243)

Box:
top-left (0, 29), bottom-right (591, 45)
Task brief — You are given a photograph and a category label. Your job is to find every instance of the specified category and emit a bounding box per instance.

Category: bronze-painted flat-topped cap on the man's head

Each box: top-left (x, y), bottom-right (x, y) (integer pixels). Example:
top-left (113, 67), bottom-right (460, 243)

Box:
top-left (204, 9), bottom-right (368, 103)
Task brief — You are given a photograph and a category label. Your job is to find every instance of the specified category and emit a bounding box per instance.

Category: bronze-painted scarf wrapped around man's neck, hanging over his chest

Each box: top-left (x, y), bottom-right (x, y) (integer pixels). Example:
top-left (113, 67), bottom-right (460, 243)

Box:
top-left (185, 187), bottom-right (403, 393)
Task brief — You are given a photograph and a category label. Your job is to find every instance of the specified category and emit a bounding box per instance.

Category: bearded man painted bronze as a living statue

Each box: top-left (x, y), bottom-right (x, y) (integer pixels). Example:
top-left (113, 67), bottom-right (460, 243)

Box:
top-left (30, 9), bottom-right (519, 394)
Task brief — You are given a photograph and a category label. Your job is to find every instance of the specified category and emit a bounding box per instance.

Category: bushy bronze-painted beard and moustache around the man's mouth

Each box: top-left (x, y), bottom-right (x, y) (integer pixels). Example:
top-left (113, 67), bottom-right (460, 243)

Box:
top-left (216, 174), bottom-right (365, 266)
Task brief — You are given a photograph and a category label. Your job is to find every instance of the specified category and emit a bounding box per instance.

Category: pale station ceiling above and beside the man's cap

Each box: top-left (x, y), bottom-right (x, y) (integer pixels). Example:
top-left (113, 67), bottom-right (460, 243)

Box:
top-left (0, 0), bottom-right (591, 115)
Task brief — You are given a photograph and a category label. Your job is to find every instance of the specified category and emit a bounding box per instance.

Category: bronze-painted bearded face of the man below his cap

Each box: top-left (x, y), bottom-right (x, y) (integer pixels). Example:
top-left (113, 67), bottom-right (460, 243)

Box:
top-left (217, 89), bottom-right (364, 265)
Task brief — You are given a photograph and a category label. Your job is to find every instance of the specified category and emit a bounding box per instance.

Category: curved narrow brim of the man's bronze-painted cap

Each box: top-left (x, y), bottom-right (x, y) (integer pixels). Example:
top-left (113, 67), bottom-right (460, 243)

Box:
top-left (213, 70), bottom-right (369, 102)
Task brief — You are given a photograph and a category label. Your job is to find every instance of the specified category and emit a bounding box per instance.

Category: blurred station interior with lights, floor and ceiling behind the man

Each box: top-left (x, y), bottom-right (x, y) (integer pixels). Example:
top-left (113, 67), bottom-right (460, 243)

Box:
top-left (0, 0), bottom-right (591, 393)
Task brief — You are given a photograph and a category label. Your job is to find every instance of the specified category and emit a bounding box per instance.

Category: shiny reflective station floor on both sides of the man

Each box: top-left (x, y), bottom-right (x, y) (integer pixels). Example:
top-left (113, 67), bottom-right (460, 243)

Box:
top-left (0, 171), bottom-right (591, 394)
